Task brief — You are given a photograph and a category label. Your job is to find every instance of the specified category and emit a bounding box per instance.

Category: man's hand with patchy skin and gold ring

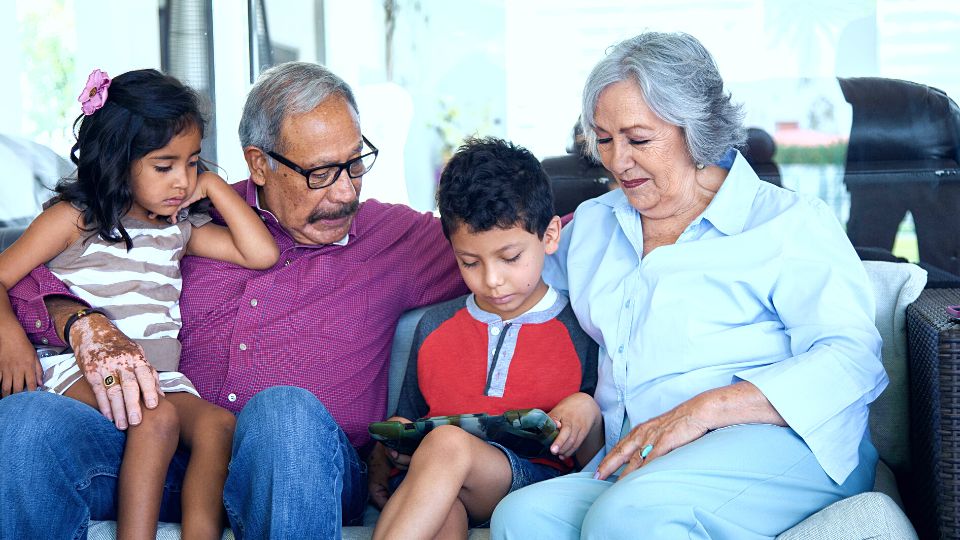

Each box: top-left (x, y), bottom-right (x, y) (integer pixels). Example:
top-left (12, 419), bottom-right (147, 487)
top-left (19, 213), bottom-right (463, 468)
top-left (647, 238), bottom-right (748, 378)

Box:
top-left (68, 313), bottom-right (162, 430)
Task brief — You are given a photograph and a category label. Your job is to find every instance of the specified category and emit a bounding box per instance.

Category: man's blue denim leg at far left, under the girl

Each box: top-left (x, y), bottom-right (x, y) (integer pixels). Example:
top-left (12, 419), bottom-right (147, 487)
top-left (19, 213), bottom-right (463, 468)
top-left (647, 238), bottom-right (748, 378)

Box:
top-left (0, 391), bottom-right (183, 538)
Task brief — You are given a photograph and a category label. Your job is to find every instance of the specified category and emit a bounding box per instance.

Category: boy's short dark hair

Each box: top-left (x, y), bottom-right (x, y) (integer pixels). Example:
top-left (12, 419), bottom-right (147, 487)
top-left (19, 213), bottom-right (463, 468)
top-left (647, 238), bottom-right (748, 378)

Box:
top-left (437, 137), bottom-right (554, 240)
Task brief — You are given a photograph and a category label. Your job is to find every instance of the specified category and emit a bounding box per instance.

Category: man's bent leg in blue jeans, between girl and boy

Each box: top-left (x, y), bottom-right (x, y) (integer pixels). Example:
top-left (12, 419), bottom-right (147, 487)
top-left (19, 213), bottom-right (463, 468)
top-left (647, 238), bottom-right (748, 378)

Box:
top-left (223, 386), bottom-right (367, 539)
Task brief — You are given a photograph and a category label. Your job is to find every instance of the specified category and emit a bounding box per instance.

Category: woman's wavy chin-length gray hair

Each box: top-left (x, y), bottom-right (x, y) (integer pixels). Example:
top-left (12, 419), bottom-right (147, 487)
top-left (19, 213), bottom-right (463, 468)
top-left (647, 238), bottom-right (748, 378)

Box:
top-left (580, 32), bottom-right (747, 165)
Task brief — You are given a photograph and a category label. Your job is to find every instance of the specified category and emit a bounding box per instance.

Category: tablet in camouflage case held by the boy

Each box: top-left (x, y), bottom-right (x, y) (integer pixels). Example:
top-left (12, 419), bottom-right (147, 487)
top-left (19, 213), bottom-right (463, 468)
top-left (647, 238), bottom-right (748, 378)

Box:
top-left (367, 409), bottom-right (559, 458)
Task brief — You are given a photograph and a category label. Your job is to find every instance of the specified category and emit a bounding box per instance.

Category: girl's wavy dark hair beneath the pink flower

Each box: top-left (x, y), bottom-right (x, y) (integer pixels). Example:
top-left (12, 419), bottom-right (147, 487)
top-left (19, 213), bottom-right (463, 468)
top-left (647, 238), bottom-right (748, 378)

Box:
top-left (55, 69), bottom-right (205, 250)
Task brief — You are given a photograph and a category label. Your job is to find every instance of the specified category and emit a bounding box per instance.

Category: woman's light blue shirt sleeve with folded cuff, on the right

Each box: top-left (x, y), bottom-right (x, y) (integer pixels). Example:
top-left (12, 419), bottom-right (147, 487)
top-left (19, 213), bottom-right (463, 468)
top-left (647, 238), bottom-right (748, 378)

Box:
top-left (737, 201), bottom-right (887, 483)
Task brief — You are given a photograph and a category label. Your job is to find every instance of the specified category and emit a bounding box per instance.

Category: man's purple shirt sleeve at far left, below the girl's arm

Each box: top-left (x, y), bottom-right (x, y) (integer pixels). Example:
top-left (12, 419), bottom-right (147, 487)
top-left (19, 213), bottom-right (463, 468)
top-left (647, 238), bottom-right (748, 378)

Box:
top-left (9, 265), bottom-right (87, 347)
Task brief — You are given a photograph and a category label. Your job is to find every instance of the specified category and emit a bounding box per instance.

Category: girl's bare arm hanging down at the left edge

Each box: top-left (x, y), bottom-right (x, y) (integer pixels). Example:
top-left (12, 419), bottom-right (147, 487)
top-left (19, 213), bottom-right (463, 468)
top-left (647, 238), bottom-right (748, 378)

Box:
top-left (0, 202), bottom-right (81, 397)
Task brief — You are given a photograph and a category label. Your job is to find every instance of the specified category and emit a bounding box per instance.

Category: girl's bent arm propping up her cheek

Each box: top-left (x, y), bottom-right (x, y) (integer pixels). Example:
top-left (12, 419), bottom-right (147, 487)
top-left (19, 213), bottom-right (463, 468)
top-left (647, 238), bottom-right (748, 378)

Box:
top-left (181, 173), bottom-right (280, 270)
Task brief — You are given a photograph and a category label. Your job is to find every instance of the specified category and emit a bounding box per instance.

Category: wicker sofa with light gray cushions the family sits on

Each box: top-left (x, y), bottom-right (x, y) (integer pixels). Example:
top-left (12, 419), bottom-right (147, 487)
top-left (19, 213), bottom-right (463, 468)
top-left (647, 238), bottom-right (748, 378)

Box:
top-left (0, 217), bottom-right (960, 540)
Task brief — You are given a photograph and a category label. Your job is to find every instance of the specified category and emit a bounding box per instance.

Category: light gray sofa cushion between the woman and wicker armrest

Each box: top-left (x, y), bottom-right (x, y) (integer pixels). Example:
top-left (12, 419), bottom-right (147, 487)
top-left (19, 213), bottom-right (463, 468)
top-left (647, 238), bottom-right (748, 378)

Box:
top-left (863, 261), bottom-right (927, 476)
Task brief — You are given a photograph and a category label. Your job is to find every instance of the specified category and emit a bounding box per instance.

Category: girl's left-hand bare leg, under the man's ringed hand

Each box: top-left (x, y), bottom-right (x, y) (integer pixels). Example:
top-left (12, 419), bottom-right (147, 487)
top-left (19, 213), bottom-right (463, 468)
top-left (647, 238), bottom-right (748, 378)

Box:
top-left (64, 380), bottom-right (180, 539)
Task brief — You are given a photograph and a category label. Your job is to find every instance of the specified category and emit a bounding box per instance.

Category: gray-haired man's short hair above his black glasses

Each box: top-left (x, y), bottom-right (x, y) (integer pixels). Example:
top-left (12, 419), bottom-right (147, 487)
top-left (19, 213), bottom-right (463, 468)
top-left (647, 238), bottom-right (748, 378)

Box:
top-left (240, 62), bottom-right (357, 156)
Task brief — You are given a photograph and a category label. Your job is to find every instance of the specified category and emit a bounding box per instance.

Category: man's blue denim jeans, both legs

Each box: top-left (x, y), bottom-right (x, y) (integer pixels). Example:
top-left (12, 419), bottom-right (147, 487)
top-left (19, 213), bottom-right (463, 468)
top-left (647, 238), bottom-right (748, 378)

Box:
top-left (0, 387), bottom-right (367, 539)
